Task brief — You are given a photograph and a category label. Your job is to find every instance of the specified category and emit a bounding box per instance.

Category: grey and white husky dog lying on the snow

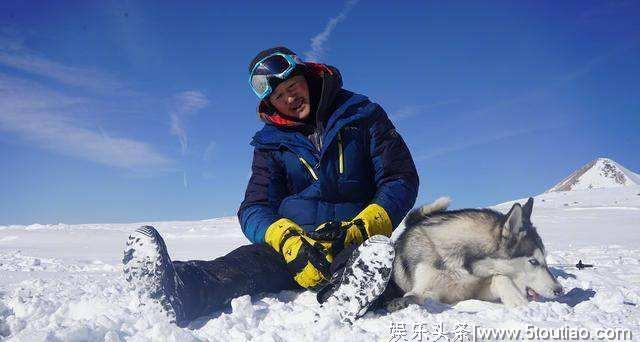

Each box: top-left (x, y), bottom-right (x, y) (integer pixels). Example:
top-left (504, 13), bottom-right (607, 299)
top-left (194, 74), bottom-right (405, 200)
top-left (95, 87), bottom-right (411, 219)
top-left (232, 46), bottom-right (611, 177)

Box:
top-left (387, 198), bottom-right (563, 310)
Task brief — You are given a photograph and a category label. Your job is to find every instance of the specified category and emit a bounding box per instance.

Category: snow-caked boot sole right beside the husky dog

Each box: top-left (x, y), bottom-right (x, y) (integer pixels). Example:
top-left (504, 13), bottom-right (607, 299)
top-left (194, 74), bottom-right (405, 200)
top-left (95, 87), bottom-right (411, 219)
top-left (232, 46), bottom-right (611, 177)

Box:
top-left (318, 235), bottom-right (395, 324)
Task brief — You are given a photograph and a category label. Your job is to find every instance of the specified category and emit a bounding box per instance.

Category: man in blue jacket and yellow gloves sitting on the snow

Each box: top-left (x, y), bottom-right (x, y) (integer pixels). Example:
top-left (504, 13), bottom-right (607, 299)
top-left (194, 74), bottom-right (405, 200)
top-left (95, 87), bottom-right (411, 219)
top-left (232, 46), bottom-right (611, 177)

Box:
top-left (123, 47), bottom-right (418, 326)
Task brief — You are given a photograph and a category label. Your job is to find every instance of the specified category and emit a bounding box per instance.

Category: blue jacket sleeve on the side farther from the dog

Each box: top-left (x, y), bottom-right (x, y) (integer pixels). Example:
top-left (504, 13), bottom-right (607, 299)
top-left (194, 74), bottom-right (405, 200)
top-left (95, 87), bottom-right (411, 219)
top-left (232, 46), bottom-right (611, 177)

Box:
top-left (238, 149), bottom-right (287, 243)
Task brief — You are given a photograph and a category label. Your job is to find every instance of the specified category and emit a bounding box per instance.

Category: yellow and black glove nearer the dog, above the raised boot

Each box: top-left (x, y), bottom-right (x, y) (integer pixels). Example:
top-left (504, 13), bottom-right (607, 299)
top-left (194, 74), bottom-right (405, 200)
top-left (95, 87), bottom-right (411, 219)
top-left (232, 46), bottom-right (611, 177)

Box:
top-left (309, 203), bottom-right (393, 255)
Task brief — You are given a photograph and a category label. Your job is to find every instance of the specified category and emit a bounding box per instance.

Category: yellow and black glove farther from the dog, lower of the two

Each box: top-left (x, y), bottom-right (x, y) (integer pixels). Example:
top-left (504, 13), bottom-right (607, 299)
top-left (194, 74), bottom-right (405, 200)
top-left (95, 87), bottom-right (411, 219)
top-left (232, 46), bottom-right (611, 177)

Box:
top-left (265, 218), bottom-right (333, 290)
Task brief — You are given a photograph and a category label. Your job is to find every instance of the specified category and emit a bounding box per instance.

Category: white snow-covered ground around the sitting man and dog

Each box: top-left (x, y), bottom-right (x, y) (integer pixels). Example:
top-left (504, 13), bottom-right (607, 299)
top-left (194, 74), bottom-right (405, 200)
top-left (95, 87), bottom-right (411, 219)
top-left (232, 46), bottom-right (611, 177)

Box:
top-left (0, 186), bottom-right (640, 341)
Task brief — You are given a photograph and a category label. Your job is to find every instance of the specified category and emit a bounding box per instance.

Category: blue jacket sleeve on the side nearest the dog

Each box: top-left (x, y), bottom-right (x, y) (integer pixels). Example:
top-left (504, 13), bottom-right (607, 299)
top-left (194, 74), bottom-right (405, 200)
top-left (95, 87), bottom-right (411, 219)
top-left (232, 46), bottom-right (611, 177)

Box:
top-left (368, 104), bottom-right (419, 228)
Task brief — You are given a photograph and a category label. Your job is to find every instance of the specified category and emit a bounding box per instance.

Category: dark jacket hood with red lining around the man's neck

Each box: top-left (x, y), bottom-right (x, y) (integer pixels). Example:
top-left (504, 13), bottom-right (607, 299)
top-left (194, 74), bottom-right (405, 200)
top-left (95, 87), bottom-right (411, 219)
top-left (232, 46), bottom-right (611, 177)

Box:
top-left (257, 62), bottom-right (342, 131)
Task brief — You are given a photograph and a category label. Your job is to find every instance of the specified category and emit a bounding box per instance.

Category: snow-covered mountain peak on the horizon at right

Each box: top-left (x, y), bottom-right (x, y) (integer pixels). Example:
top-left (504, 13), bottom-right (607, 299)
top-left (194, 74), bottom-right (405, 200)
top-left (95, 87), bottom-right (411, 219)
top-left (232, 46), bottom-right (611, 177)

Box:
top-left (546, 158), bottom-right (640, 192)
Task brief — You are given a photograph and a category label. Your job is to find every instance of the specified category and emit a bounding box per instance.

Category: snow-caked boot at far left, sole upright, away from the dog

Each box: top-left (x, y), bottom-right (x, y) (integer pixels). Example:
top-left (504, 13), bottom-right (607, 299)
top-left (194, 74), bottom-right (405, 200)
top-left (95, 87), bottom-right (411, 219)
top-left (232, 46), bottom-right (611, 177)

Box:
top-left (122, 226), bottom-right (188, 326)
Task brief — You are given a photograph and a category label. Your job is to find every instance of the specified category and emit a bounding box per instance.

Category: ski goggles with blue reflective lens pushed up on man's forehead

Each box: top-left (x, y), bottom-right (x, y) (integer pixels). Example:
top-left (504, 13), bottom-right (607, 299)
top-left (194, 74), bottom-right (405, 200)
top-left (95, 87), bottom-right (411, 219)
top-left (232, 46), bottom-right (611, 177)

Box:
top-left (249, 52), bottom-right (304, 100)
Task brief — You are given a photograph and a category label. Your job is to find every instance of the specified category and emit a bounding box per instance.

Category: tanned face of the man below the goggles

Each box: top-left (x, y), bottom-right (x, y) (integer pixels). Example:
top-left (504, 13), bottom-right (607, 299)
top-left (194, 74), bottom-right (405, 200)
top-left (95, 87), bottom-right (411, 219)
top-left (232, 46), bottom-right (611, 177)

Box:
top-left (269, 75), bottom-right (311, 120)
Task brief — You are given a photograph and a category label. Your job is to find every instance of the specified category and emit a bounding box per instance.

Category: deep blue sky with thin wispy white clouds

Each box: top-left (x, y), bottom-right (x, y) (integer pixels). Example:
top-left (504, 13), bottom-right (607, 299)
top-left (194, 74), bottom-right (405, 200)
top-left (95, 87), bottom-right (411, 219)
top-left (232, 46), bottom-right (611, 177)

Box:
top-left (0, 0), bottom-right (640, 225)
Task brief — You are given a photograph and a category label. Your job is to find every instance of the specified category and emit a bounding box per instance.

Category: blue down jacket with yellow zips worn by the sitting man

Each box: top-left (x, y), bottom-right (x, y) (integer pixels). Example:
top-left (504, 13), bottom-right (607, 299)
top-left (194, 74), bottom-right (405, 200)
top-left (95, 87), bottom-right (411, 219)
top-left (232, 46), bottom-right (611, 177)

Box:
top-left (238, 62), bottom-right (418, 243)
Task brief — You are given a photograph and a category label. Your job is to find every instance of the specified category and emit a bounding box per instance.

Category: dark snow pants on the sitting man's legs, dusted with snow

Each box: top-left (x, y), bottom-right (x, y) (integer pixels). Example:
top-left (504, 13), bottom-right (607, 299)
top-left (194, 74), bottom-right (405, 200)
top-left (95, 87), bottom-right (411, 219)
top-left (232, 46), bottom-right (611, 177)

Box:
top-left (173, 244), bottom-right (400, 324)
